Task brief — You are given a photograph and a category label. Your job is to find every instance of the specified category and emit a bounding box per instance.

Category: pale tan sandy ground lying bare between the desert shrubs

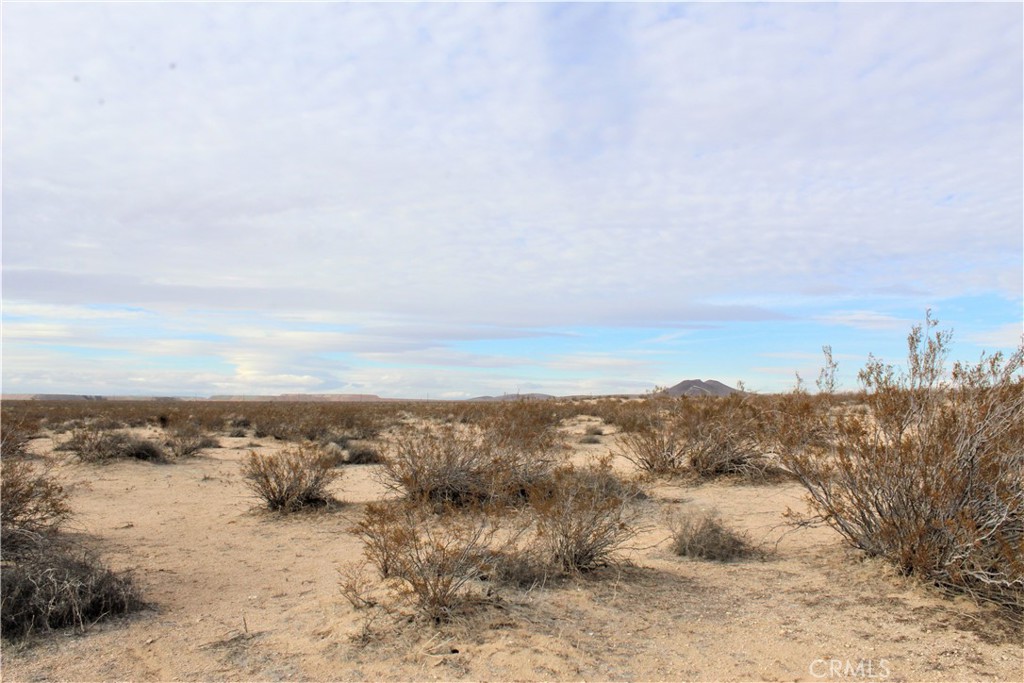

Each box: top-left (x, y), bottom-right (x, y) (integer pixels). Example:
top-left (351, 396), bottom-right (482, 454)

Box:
top-left (2, 419), bottom-right (1024, 681)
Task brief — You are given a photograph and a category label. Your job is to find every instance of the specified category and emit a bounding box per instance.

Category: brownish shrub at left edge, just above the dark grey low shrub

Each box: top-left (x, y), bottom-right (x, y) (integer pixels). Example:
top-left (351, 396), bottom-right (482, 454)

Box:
top-left (0, 458), bottom-right (71, 551)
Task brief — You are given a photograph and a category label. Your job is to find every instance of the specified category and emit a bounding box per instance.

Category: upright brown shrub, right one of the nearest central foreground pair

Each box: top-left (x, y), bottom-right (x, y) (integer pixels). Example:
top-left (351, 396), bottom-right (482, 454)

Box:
top-left (529, 459), bottom-right (639, 573)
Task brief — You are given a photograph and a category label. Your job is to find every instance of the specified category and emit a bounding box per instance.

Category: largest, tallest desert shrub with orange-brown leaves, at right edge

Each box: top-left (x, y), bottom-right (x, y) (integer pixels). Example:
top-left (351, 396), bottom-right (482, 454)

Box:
top-left (777, 315), bottom-right (1024, 610)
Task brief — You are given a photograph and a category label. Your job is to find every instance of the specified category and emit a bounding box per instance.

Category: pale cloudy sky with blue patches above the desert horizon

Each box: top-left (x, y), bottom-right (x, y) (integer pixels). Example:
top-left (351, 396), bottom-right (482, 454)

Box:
top-left (2, 2), bottom-right (1024, 398)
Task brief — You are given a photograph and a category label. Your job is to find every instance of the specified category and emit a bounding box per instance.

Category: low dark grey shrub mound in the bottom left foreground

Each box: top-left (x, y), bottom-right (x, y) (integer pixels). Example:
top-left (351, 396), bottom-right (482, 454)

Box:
top-left (0, 543), bottom-right (142, 639)
